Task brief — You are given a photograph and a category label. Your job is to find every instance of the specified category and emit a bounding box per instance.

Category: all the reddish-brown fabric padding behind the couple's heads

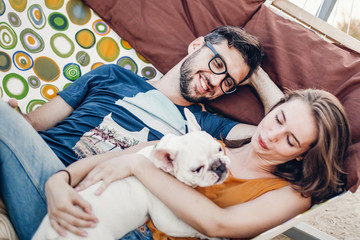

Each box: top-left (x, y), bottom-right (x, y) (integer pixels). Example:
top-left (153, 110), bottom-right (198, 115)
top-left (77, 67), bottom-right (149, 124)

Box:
top-left (84, 0), bottom-right (360, 191)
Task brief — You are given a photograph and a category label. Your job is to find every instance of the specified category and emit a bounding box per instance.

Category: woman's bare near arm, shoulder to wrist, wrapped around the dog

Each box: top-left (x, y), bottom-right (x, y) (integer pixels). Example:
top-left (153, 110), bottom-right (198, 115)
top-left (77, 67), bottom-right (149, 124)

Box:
top-left (131, 156), bottom-right (310, 238)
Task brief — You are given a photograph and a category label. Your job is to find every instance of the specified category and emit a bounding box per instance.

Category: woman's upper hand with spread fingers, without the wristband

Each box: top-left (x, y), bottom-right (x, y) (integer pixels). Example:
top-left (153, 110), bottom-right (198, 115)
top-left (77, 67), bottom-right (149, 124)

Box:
top-left (75, 153), bottom-right (144, 195)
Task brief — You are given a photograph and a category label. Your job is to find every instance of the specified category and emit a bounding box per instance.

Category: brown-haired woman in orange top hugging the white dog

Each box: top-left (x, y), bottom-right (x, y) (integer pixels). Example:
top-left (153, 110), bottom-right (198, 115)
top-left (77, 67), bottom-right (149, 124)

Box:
top-left (46, 89), bottom-right (350, 239)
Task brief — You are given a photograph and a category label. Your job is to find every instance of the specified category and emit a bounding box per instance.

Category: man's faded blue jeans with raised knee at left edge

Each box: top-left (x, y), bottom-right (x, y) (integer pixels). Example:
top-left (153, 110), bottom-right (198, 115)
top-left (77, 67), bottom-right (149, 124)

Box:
top-left (0, 100), bottom-right (65, 240)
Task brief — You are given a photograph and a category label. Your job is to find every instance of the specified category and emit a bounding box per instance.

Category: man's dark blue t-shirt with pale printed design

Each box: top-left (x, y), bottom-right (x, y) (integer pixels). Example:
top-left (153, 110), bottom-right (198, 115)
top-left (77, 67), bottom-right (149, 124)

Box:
top-left (39, 64), bottom-right (236, 165)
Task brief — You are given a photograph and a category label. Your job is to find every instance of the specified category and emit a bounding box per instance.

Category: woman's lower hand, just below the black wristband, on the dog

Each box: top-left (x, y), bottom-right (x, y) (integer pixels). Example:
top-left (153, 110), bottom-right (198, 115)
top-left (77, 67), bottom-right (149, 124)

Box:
top-left (45, 173), bottom-right (98, 236)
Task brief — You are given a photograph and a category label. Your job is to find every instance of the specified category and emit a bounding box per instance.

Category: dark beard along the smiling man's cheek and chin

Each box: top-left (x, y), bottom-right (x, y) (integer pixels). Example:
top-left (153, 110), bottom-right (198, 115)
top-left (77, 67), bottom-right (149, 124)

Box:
top-left (180, 51), bottom-right (209, 103)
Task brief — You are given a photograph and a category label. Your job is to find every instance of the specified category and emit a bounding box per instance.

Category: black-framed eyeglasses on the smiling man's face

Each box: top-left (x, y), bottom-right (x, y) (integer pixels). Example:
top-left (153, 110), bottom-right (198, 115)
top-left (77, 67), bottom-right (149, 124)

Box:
top-left (205, 41), bottom-right (237, 94)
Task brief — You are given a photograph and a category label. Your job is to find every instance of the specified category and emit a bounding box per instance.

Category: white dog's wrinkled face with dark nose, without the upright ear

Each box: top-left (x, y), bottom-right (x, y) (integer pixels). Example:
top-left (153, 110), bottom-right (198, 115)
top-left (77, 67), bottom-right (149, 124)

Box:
top-left (153, 131), bottom-right (230, 187)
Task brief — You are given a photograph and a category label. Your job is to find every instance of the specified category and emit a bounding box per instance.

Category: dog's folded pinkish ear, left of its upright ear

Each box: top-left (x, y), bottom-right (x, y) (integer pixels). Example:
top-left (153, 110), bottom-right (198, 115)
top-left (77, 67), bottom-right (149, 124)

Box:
top-left (153, 147), bottom-right (177, 174)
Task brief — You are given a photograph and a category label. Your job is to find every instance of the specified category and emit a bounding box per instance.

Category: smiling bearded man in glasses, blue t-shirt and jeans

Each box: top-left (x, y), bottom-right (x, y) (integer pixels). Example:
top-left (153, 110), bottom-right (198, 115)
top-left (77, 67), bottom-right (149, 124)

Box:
top-left (0, 26), bottom-right (282, 239)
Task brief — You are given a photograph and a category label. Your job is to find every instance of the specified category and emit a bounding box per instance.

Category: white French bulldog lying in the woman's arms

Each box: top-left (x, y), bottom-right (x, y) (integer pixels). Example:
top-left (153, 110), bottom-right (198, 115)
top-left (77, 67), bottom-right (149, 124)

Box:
top-left (32, 109), bottom-right (230, 240)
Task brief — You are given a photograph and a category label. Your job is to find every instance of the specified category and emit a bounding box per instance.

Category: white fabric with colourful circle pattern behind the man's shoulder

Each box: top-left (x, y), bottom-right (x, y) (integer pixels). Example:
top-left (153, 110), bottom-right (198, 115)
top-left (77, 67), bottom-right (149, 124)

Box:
top-left (0, 0), bottom-right (160, 112)
